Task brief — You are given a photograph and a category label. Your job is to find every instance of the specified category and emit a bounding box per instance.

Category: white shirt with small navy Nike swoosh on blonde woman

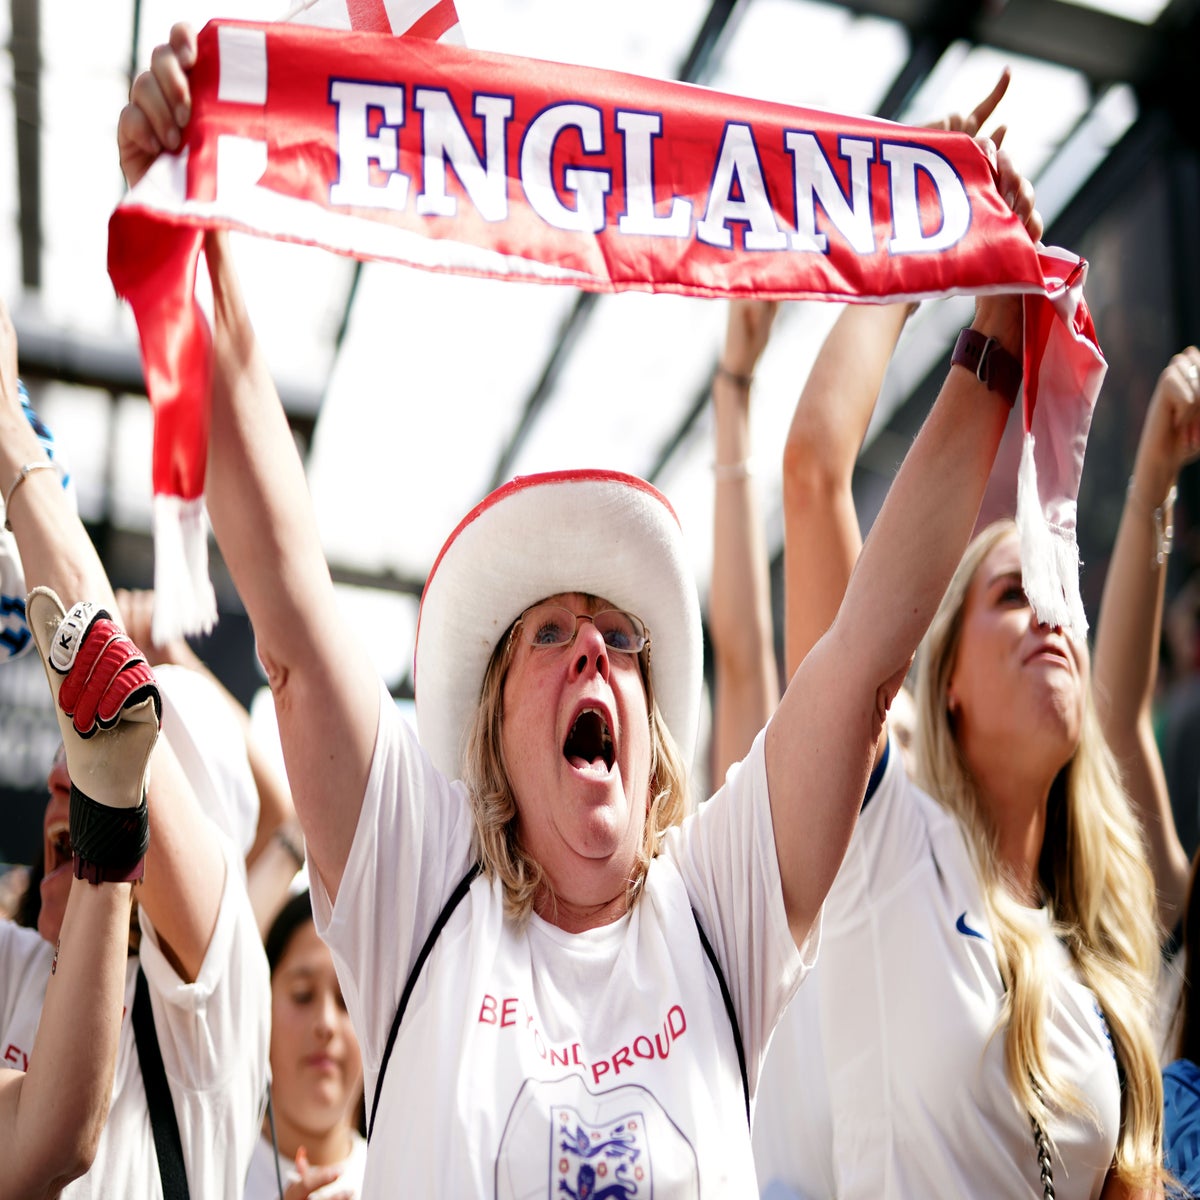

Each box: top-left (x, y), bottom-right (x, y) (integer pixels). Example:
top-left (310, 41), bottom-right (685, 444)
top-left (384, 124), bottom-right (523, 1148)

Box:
top-left (754, 754), bottom-right (1120, 1200)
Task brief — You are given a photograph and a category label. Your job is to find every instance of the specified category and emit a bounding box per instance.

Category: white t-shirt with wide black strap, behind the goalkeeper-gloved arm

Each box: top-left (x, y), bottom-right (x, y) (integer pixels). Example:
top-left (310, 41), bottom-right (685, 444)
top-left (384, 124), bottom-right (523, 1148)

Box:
top-left (0, 838), bottom-right (271, 1200)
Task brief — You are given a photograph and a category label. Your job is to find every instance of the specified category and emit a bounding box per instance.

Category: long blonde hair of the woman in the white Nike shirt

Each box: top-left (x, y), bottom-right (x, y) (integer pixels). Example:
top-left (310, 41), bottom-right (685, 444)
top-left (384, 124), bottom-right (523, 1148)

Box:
top-left (916, 521), bottom-right (1163, 1188)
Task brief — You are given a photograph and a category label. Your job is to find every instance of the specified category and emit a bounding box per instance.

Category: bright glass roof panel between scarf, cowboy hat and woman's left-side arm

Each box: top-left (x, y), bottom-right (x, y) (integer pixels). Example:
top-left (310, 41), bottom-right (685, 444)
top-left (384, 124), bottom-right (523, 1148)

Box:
top-left (310, 264), bottom-right (575, 578)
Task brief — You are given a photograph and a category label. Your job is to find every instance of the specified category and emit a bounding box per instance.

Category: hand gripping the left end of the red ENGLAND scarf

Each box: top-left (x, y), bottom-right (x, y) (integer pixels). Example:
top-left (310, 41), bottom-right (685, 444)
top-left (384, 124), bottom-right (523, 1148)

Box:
top-left (116, 22), bottom-right (196, 187)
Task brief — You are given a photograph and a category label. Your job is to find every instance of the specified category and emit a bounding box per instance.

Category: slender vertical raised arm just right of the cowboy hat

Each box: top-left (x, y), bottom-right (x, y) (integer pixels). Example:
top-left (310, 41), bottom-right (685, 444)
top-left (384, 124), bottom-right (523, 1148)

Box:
top-left (708, 300), bottom-right (779, 786)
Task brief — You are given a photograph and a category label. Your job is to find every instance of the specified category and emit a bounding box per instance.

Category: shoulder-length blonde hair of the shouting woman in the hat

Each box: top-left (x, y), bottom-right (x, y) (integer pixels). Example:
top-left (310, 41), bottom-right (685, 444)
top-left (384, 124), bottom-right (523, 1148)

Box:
top-left (462, 598), bottom-right (688, 923)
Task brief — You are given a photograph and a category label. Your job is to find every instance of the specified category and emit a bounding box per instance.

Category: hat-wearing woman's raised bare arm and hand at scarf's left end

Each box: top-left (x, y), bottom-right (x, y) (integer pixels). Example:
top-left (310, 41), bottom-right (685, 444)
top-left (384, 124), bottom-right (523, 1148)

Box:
top-left (118, 25), bottom-right (379, 896)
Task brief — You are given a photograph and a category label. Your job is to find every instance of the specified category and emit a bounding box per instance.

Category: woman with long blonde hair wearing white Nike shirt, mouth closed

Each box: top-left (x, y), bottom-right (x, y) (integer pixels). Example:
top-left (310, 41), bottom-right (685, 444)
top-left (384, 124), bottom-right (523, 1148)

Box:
top-left (755, 295), bottom-right (1162, 1200)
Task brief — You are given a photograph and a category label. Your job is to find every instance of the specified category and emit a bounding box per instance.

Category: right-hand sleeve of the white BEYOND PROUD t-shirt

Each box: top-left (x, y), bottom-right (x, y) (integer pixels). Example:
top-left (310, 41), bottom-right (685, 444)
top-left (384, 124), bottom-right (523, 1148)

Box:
top-left (664, 733), bottom-right (821, 1094)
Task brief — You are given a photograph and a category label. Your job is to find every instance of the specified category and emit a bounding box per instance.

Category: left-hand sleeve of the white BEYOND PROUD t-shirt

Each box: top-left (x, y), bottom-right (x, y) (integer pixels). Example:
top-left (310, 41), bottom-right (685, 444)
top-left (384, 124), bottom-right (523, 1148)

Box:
top-left (311, 684), bottom-right (473, 1078)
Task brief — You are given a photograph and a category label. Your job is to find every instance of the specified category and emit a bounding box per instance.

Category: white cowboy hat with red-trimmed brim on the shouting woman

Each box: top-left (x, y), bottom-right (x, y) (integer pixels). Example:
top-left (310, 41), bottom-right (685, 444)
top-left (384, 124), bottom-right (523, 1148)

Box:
top-left (414, 470), bottom-right (703, 779)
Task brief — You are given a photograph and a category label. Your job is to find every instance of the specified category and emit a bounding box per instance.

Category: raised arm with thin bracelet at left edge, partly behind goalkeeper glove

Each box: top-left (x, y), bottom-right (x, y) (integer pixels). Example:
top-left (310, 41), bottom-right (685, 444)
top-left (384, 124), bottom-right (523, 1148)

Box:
top-left (0, 306), bottom-right (224, 980)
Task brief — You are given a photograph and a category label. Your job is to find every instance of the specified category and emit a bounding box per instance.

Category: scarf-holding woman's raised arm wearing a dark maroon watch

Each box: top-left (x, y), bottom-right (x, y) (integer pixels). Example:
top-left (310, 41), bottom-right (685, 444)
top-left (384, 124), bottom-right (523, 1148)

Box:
top-left (767, 136), bottom-right (1042, 940)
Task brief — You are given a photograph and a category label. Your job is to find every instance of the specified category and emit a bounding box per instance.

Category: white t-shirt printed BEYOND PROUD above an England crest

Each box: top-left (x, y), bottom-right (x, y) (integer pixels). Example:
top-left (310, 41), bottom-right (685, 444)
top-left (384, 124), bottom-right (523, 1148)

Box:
top-left (312, 692), bottom-right (818, 1200)
